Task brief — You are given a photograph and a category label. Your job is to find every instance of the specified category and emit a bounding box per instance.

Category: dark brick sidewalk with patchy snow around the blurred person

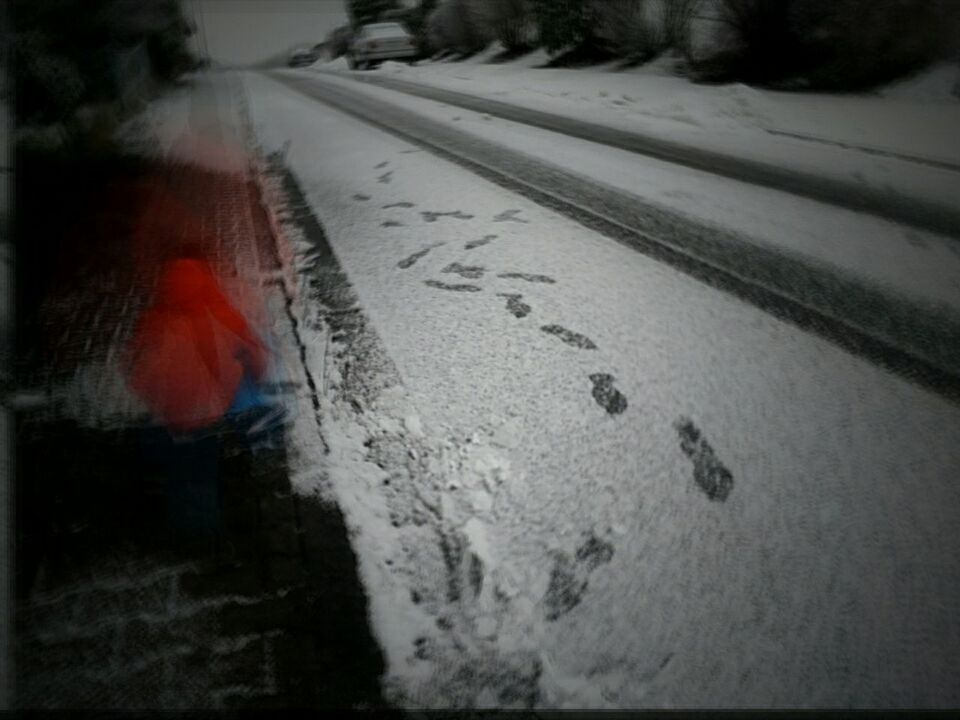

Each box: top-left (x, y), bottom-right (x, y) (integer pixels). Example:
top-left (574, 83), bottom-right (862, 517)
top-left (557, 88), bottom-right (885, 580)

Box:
top-left (15, 71), bottom-right (382, 710)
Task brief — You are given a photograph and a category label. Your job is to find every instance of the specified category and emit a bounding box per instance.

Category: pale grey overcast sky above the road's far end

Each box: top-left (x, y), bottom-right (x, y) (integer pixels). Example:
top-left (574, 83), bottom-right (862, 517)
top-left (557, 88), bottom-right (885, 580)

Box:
top-left (183, 0), bottom-right (347, 64)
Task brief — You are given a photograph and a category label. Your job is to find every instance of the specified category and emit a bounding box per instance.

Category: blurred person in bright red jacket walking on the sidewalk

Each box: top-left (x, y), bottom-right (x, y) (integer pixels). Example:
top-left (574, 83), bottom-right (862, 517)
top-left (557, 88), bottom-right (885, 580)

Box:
top-left (126, 245), bottom-right (272, 533)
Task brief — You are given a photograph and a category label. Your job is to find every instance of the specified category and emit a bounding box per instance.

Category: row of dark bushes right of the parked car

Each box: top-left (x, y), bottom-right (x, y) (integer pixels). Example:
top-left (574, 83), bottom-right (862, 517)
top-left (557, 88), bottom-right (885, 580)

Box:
top-left (426, 0), bottom-right (960, 90)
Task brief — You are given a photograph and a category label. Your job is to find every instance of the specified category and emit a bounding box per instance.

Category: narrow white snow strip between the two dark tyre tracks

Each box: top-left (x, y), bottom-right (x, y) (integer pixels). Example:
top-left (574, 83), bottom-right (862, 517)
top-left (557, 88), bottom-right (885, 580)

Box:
top-left (281, 71), bottom-right (960, 316)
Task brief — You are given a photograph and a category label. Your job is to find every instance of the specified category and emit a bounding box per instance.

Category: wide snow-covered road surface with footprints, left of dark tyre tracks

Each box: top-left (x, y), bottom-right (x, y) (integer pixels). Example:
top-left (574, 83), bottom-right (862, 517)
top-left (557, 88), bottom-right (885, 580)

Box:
top-left (238, 69), bottom-right (960, 707)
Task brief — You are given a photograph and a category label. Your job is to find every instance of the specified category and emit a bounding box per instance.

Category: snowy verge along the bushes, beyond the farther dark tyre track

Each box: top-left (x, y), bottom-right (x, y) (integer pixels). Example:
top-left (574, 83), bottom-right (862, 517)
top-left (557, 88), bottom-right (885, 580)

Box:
top-left (320, 45), bottom-right (960, 165)
